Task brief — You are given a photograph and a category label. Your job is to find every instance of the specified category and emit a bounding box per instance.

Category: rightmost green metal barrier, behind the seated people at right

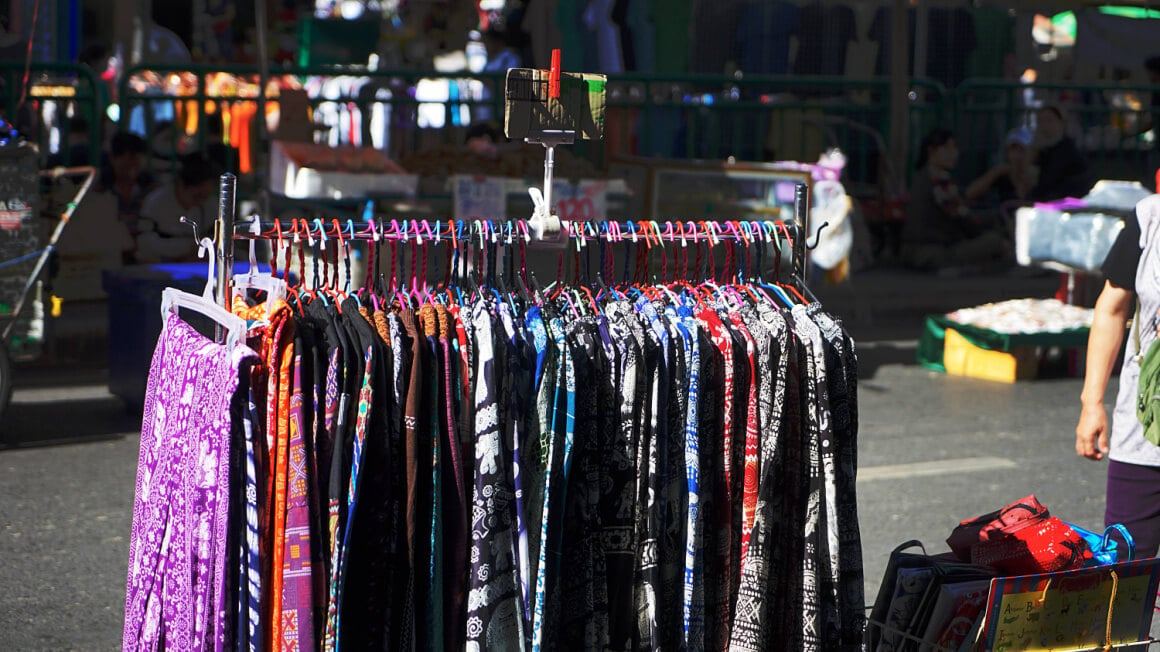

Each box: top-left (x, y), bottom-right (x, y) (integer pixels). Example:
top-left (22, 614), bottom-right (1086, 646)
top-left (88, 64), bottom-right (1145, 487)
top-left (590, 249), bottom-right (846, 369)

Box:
top-left (952, 80), bottom-right (1160, 188)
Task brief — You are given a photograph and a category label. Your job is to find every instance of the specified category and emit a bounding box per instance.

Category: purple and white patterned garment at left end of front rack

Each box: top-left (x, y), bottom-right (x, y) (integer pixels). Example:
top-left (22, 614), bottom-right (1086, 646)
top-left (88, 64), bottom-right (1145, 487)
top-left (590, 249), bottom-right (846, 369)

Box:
top-left (122, 314), bottom-right (255, 651)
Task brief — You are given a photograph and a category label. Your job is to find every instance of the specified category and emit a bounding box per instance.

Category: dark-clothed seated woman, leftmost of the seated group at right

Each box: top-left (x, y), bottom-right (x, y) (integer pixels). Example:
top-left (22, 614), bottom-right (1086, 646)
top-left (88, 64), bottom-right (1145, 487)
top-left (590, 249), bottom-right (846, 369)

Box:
top-left (901, 129), bottom-right (1013, 269)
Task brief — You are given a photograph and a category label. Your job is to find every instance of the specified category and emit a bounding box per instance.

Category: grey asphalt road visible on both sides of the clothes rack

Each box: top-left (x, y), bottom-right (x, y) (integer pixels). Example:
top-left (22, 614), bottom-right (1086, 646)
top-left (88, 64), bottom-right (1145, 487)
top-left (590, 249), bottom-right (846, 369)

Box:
top-left (0, 343), bottom-right (1112, 651)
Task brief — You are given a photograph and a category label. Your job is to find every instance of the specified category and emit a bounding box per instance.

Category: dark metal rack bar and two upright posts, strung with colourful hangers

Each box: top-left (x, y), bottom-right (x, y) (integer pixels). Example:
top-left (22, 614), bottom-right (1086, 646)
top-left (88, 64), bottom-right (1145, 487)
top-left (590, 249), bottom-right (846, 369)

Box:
top-left (206, 173), bottom-right (826, 310)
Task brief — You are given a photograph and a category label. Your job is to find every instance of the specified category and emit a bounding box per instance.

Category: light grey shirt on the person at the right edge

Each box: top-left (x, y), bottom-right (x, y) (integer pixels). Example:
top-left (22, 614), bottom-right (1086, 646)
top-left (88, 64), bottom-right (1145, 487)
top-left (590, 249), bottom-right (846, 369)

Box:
top-left (1108, 195), bottom-right (1160, 466)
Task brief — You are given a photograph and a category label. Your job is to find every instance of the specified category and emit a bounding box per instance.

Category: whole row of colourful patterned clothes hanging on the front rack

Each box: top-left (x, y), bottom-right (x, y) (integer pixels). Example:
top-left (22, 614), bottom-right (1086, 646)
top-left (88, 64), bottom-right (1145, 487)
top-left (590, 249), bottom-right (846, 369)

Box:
top-left (124, 211), bottom-right (864, 650)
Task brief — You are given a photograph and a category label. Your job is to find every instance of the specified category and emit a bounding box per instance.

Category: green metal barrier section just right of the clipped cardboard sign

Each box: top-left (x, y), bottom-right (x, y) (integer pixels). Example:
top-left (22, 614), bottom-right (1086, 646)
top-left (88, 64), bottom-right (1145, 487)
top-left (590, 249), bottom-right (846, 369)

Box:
top-left (603, 75), bottom-right (947, 189)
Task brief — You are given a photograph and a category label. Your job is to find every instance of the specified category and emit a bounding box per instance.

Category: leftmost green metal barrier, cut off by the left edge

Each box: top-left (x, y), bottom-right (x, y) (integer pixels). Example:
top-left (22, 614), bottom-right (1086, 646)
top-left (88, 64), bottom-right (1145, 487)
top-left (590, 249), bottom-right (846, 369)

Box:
top-left (0, 61), bottom-right (108, 166)
